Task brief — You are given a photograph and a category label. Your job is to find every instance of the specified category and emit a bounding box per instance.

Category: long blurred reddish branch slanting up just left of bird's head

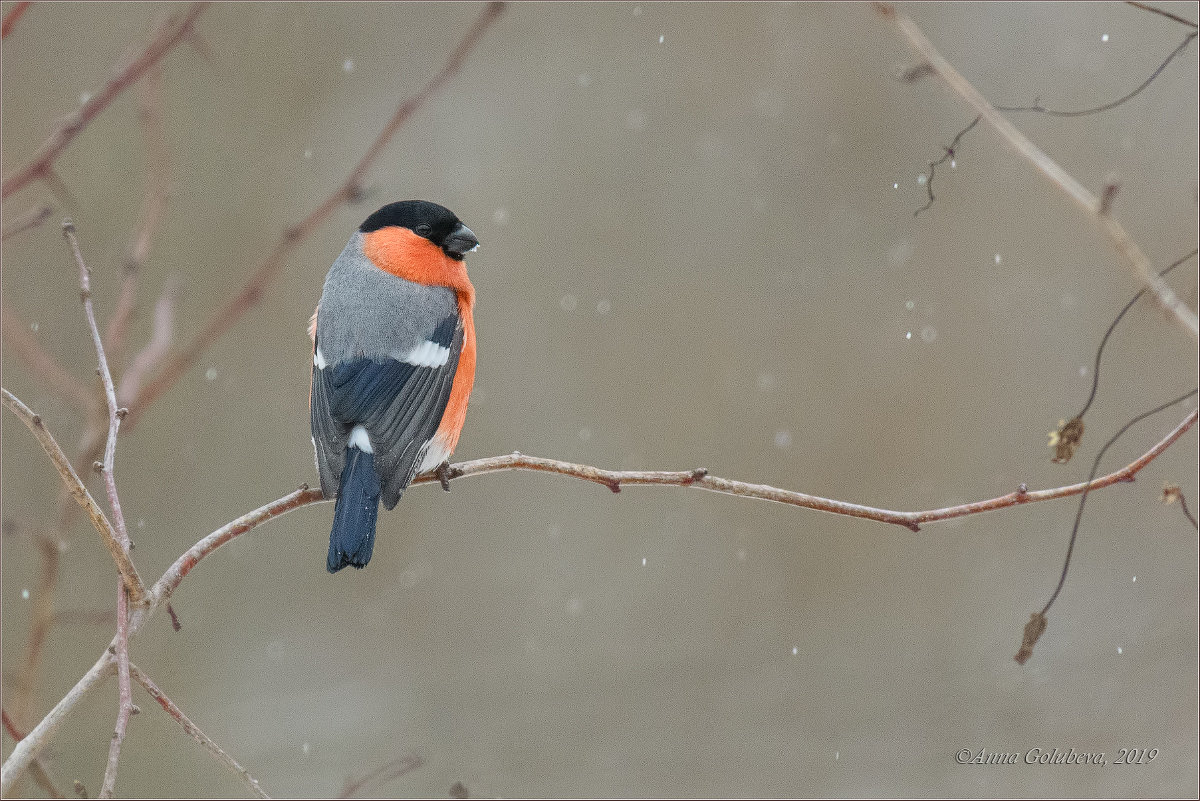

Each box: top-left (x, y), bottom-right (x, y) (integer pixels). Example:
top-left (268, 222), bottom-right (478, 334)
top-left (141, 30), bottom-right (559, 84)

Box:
top-left (126, 2), bottom-right (504, 426)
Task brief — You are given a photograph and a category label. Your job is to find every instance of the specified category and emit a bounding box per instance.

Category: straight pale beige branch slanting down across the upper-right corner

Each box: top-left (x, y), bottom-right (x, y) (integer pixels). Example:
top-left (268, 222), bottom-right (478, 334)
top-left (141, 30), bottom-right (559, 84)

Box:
top-left (877, 6), bottom-right (1200, 338)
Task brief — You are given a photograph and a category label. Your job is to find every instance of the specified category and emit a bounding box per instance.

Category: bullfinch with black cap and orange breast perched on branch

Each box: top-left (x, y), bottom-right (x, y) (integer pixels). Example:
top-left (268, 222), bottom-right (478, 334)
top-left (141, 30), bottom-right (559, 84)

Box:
top-left (308, 200), bottom-right (479, 573)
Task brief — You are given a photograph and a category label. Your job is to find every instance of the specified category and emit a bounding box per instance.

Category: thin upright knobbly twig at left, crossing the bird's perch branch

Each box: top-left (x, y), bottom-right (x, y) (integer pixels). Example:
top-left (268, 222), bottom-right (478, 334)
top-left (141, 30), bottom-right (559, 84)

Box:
top-left (62, 221), bottom-right (133, 799)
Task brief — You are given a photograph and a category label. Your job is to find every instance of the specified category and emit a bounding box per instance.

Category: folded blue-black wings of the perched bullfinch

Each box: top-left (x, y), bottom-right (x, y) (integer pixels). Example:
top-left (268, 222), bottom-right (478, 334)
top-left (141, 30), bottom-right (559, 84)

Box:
top-left (311, 314), bottom-right (463, 508)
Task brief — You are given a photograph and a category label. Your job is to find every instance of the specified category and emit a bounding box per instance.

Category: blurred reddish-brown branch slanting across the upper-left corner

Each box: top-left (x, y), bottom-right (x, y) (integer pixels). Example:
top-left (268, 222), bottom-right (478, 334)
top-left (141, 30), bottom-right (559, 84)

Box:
top-left (0, 2), bottom-right (208, 198)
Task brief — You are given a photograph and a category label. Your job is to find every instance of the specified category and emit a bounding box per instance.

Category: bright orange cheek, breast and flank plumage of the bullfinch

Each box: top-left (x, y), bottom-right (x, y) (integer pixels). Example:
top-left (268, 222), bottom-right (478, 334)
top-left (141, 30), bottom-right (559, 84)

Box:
top-left (362, 225), bottom-right (475, 451)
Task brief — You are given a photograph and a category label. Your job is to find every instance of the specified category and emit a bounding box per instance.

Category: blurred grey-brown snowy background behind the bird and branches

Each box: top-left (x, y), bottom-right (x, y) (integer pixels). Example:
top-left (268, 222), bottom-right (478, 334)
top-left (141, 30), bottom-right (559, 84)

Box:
top-left (0, 2), bottom-right (1200, 796)
